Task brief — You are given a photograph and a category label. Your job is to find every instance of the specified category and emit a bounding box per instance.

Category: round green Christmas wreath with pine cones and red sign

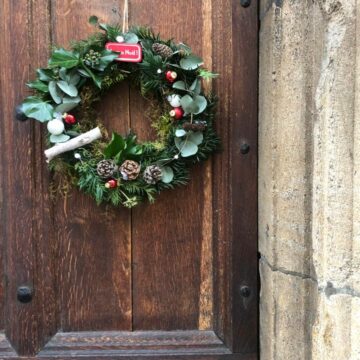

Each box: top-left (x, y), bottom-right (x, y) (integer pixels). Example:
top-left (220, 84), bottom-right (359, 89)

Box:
top-left (16, 17), bottom-right (219, 208)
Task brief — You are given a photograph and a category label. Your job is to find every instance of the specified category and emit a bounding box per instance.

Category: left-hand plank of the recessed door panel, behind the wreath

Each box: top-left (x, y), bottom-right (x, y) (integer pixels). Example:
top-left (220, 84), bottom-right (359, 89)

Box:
top-left (51, 0), bottom-right (131, 331)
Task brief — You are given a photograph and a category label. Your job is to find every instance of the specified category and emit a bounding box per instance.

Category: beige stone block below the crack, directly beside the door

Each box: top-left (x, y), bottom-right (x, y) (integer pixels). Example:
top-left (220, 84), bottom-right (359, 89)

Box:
top-left (260, 261), bottom-right (316, 360)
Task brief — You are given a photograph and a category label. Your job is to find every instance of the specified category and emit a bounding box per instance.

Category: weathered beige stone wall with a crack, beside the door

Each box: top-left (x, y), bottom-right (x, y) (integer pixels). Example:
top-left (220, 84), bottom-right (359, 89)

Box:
top-left (259, 0), bottom-right (360, 360)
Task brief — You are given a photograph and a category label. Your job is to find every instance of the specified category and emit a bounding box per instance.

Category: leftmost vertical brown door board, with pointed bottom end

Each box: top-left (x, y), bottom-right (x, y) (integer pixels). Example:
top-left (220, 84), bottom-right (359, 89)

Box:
top-left (0, 0), bottom-right (56, 354)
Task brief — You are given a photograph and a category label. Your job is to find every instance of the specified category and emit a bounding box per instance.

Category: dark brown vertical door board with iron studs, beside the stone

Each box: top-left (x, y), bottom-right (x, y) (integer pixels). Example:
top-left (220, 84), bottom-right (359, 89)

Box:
top-left (213, 0), bottom-right (258, 353)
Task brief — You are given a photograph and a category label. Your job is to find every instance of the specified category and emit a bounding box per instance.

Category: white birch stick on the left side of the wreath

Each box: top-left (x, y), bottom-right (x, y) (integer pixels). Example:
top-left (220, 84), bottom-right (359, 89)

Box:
top-left (44, 127), bottom-right (102, 162)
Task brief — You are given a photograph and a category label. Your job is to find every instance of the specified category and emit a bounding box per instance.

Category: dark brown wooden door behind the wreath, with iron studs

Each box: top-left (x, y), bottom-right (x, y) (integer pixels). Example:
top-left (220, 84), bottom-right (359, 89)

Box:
top-left (0, 0), bottom-right (258, 360)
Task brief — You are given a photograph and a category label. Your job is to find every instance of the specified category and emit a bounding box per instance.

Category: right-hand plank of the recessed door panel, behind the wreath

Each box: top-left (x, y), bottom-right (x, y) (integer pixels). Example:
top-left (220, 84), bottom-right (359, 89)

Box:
top-left (130, 0), bottom-right (211, 330)
